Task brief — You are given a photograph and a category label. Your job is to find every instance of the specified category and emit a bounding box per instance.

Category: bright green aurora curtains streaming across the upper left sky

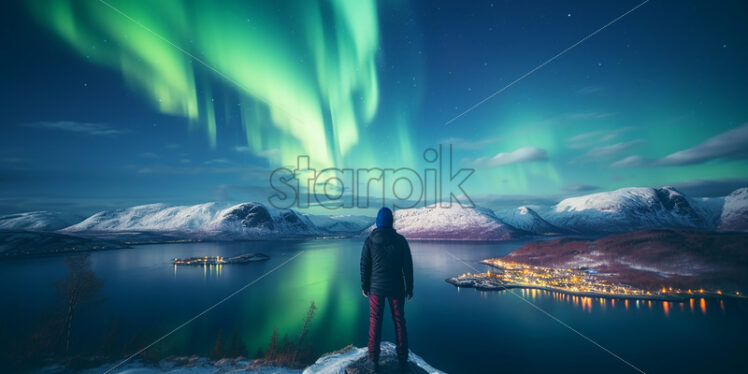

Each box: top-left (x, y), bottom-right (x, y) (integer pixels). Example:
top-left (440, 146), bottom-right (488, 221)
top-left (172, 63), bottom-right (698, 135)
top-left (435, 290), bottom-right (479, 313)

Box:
top-left (30, 0), bottom-right (388, 166)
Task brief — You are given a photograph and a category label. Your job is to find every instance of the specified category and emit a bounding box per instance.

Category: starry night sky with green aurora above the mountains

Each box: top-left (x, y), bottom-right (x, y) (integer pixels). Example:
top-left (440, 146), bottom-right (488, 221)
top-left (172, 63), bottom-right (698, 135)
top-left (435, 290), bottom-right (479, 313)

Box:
top-left (0, 0), bottom-right (748, 213)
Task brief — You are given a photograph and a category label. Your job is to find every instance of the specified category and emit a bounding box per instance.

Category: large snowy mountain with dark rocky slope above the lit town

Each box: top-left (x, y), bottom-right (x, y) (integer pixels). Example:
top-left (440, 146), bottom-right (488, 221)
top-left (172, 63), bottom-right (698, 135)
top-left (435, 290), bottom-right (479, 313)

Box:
top-left (544, 187), bottom-right (715, 233)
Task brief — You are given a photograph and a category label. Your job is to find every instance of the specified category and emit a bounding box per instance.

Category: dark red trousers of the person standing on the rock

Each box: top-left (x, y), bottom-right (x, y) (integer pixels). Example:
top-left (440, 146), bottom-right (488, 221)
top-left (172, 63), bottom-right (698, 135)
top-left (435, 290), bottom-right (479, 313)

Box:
top-left (369, 295), bottom-right (408, 362)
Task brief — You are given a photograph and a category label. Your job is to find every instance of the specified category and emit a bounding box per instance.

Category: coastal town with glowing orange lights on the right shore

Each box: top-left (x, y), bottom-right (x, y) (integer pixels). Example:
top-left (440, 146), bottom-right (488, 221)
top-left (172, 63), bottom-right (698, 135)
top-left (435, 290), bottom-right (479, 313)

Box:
top-left (447, 258), bottom-right (742, 301)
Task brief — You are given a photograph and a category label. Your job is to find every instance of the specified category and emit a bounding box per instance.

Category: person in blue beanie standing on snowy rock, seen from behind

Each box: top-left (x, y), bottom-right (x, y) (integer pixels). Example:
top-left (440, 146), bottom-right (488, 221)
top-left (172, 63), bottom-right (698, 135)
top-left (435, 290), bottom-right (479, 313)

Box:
top-left (361, 208), bottom-right (413, 371)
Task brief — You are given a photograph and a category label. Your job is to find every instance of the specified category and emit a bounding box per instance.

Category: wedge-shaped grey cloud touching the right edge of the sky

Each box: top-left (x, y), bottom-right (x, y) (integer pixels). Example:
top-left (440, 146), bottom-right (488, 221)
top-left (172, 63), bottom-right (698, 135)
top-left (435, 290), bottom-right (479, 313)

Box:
top-left (657, 123), bottom-right (748, 166)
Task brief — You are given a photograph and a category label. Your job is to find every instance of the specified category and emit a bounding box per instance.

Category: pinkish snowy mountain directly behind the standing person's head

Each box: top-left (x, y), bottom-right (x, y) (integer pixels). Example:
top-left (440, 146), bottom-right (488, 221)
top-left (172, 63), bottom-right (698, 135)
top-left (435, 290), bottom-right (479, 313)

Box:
top-left (369, 204), bottom-right (524, 240)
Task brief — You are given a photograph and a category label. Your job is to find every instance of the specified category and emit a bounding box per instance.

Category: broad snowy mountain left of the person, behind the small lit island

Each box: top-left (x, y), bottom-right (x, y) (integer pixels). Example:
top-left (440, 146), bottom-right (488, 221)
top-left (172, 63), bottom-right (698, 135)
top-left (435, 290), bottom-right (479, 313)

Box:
top-left (62, 203), bottom-right (325, 239)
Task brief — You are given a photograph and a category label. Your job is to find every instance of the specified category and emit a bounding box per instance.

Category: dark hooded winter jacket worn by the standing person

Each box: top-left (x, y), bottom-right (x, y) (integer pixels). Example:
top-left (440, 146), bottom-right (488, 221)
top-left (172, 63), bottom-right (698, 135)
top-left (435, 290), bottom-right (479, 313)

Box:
top-left (361, 227), bottom-right (413, 298)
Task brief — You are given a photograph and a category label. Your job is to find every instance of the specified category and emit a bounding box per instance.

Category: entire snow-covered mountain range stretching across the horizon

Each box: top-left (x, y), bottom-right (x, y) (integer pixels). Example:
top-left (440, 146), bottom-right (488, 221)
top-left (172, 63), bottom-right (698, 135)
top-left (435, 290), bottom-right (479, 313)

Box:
top-left (0, 187), bottom-right (748, 242)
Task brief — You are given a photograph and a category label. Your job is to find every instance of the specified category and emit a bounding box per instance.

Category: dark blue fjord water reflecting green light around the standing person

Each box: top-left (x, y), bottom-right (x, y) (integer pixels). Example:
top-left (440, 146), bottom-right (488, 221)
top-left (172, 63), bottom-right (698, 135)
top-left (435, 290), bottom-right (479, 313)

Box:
top-left (0, 239), bottom-right (748, 373)
